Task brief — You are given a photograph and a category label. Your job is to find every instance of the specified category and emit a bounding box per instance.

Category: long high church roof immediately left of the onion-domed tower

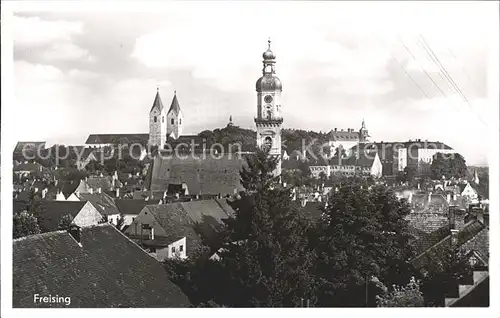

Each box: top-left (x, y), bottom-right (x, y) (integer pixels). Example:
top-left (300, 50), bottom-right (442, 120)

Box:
top-left (147, 156), bottom-right (244, 195)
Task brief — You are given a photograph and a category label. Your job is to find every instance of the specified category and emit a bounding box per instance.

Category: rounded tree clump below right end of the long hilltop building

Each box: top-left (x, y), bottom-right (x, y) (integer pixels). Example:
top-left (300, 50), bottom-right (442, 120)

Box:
top-left (430, 152), bottom-right (467, 180)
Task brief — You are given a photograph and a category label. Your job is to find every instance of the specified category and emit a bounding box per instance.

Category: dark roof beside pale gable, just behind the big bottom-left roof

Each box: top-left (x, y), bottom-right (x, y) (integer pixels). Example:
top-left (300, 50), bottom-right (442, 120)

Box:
top-left (38, 201), bottom-right (87, 233)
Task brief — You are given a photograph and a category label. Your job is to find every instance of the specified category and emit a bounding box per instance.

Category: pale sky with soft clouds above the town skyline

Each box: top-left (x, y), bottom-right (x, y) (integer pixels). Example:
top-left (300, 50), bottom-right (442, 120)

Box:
top-left (7, 1), bottom-right (497, 164)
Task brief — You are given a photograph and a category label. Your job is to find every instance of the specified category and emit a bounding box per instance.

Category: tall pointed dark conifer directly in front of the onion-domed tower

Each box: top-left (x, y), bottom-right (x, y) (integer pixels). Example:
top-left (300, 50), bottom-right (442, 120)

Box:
top-left (215, 149), bottom-right (314, 307)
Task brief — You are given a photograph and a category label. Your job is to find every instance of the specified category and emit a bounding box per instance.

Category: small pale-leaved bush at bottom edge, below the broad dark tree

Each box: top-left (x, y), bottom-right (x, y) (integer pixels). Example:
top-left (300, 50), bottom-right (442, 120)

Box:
top-left (376, 277), bottom-right (424, 307)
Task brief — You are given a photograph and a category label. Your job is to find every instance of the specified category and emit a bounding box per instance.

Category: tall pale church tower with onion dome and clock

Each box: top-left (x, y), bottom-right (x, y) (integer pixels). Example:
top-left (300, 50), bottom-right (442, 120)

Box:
top-left (255, 40), bottom-right (283, 175)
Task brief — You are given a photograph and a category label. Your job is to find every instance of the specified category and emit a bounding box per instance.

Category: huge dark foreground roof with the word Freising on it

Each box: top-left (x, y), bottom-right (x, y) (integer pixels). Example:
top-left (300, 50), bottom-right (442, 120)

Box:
top-left (12, 224), bottom-right (190, 308)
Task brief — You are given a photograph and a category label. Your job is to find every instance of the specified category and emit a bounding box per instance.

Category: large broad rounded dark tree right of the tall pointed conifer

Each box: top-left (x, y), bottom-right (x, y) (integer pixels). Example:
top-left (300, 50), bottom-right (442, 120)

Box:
top-left (311, 178), bottom-right (413, 307)
